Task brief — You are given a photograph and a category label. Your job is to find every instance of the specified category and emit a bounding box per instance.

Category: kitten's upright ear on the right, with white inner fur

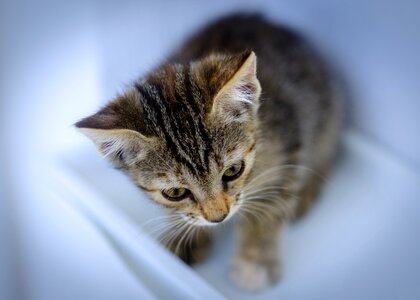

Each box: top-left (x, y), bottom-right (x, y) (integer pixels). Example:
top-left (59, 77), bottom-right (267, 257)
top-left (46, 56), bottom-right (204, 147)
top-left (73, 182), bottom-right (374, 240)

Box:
top-left (211, 51), bottom-right (261, 122)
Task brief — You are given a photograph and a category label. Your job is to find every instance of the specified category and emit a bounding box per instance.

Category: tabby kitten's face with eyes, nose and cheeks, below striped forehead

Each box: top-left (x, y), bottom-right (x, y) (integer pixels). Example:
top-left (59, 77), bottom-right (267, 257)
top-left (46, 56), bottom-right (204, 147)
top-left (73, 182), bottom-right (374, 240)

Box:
top-left (128, 119), bottom-right (255, 225)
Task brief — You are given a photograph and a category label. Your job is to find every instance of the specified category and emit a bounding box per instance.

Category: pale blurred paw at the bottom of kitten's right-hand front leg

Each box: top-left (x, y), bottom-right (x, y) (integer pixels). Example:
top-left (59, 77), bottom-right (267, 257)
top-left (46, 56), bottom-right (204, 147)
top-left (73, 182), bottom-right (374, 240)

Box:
top-left (230, 256), bottom-right (280, 292)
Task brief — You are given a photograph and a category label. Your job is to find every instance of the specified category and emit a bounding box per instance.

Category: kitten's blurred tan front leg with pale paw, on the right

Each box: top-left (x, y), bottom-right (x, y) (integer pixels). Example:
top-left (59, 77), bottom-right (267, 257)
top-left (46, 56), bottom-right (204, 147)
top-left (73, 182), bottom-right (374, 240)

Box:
top-left (230, 216), bottom-right (283, 292)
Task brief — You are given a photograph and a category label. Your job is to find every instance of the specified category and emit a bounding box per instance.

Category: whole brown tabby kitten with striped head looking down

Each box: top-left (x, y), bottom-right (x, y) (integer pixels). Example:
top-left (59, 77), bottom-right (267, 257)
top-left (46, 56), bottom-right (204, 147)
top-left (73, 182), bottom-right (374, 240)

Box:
top-left (76, 15), bottom-right (341, 291)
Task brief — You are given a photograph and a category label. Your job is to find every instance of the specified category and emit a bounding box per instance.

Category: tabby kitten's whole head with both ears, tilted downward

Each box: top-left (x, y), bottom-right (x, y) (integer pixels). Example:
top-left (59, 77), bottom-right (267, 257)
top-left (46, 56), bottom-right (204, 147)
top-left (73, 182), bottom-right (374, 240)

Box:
top-left (76, 52), bottom-right (261, 225)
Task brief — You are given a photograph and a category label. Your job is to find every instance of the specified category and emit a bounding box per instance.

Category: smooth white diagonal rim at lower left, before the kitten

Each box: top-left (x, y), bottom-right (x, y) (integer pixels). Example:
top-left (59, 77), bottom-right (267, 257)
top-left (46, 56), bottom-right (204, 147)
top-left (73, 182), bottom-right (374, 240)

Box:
top-left (53, 163), bottom-right (224, 300)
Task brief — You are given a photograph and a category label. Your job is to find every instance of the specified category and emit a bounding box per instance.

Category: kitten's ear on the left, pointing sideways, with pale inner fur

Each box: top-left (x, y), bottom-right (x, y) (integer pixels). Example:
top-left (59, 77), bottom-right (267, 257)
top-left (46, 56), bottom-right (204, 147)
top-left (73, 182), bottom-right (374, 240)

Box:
top-left (75, 92), bottom-right (153, 166)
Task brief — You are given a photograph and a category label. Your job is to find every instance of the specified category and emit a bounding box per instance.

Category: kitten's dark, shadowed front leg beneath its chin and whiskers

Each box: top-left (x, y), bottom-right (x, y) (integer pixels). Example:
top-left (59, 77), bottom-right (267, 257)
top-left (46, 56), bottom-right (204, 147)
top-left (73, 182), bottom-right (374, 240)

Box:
top-left (167, 228), bottom-right (212, 265)
